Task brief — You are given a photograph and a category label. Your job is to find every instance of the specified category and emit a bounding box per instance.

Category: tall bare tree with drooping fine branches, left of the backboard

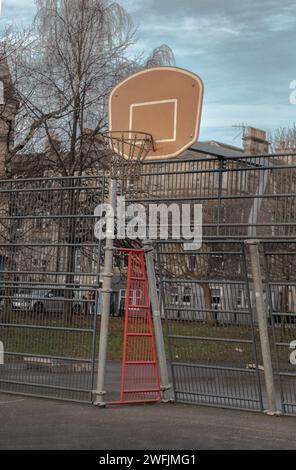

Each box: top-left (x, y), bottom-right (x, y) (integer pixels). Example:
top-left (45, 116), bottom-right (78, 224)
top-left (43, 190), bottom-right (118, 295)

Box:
top-left (1, 0), bottom-right (173, 318)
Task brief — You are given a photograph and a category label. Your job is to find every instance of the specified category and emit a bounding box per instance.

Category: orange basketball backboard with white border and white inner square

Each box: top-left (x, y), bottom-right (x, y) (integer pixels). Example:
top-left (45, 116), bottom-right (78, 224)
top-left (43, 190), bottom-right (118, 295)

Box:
top-left (109, 67), bottom-right (203, 159)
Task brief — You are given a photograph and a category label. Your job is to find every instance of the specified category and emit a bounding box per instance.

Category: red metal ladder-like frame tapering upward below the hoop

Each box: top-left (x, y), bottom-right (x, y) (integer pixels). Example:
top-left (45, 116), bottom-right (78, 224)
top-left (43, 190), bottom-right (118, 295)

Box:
top-left (117, 250), bottom-right (160, 404)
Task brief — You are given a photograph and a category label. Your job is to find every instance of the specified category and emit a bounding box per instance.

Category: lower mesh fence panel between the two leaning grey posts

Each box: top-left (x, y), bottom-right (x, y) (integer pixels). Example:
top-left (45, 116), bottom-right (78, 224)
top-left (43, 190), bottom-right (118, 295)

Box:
top-left (158, 243), bottom-right (263, 410)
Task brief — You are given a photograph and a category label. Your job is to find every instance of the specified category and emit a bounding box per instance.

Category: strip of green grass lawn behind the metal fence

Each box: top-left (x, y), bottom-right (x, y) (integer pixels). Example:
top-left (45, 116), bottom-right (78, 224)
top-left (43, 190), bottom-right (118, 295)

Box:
top-left (0, 313), bottom-right (296, 370)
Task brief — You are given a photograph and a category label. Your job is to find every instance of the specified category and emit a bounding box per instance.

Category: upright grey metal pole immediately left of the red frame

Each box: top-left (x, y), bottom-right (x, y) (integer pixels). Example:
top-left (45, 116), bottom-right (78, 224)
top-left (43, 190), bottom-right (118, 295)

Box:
top-left (94, 180), bottom-right (116, 407)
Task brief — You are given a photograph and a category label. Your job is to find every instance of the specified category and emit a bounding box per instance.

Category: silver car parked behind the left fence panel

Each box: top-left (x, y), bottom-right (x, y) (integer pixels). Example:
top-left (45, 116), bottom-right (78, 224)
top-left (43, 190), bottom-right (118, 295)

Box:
top-left (1, 287), bottom-right (84, 314)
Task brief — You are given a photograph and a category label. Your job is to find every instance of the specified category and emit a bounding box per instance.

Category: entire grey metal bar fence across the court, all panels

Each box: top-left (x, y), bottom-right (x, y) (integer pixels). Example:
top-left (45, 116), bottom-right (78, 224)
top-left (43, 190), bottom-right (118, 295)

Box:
top-left (0, 152), bottom-right (296, 414)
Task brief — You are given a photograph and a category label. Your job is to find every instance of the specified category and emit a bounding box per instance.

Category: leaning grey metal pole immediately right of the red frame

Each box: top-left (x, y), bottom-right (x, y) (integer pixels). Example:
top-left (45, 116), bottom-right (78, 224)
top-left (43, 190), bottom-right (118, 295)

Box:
top-left (143, 240), bottom-right (173, 402)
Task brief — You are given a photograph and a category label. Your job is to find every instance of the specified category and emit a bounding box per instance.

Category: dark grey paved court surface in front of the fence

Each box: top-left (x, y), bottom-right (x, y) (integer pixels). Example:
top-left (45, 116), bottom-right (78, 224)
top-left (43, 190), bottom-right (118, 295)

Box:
top-left (0, 394), bottom-right (296, 450)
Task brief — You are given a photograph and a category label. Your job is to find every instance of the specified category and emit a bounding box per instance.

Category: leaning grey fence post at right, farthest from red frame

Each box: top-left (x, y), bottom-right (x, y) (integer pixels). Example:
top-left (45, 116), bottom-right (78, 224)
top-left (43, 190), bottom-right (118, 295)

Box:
top-left (245, 240), bottom-right (280, 415)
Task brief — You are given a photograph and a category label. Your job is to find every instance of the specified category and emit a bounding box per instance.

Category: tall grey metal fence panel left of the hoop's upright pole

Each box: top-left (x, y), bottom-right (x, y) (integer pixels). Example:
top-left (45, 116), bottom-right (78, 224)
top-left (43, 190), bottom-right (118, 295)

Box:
top-left (0, 177), bottom-right (105, 401)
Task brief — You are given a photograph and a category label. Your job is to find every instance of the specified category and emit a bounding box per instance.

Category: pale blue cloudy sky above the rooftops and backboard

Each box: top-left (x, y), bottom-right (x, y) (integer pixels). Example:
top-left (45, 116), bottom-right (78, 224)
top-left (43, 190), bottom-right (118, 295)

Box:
top-left (0, 0), bottom-right (296, 145)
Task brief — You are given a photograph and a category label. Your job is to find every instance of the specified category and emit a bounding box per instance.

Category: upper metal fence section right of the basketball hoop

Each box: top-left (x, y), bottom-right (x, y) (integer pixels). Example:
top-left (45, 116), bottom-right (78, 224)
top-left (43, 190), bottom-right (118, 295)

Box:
top-left (130, 155), bottom-right (296, 240)
